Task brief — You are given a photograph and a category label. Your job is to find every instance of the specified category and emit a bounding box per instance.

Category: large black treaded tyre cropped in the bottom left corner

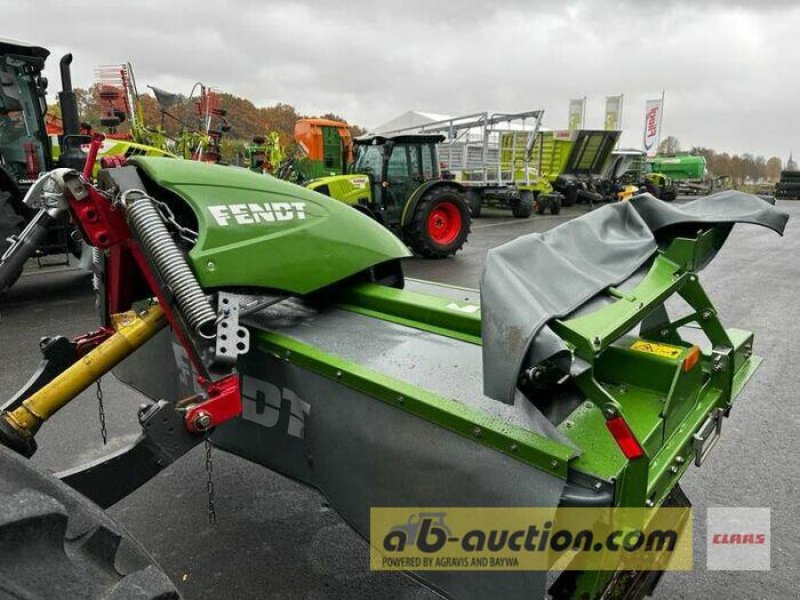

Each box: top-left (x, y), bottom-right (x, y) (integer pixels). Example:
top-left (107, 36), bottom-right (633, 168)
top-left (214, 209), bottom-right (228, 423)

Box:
top-left (0, 446), bottom-right (180, 600)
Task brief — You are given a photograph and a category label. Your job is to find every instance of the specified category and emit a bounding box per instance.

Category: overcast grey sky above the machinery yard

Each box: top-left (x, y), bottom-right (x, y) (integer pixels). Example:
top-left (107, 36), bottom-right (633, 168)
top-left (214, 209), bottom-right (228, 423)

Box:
top-left (0, 0), bottom-right (800, 160)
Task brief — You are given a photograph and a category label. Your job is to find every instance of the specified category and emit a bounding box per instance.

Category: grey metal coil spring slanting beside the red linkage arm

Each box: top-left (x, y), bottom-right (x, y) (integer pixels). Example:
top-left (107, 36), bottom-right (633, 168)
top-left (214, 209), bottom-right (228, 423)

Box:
top-left (126, 196), bottom-right (217, 339)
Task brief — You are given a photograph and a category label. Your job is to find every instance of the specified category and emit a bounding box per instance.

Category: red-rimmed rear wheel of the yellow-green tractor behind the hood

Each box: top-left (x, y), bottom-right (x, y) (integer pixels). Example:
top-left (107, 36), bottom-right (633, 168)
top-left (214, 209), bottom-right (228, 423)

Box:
top-left (404, 185), bottom-right (471, 258)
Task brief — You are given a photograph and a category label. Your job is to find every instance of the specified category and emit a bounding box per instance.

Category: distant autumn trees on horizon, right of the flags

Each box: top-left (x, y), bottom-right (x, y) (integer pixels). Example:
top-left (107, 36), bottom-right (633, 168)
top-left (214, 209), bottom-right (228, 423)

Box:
top-left (658, 136), bottom-right (783, 185)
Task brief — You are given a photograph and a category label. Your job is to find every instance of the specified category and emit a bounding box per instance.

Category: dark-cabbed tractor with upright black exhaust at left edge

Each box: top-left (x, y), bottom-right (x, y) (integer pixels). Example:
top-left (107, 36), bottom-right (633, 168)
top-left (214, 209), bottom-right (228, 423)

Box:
top-left (0, 40), bottom-right (172, 294)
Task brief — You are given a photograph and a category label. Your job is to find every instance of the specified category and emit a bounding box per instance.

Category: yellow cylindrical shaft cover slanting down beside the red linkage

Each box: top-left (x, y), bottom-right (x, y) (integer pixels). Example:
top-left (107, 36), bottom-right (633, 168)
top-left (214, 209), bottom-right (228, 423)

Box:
top-left (6, 305), bottom-right (167, 435)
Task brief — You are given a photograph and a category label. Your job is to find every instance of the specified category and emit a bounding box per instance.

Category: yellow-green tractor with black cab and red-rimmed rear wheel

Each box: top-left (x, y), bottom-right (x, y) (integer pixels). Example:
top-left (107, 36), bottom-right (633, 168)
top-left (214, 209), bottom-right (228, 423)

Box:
top-left (306, 134), bottom-right (471, 258)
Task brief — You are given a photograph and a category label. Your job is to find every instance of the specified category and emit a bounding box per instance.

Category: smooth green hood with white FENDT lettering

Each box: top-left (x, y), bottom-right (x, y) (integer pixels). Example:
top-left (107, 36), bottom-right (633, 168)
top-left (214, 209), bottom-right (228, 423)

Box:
top-left (130, 157), bottom-right (410, 294)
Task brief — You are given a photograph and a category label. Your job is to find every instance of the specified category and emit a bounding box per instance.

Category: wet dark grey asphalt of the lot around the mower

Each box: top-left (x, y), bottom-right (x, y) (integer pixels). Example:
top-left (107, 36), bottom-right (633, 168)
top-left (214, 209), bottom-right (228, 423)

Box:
top-left (0, 202), bottom-right (800, 600)
